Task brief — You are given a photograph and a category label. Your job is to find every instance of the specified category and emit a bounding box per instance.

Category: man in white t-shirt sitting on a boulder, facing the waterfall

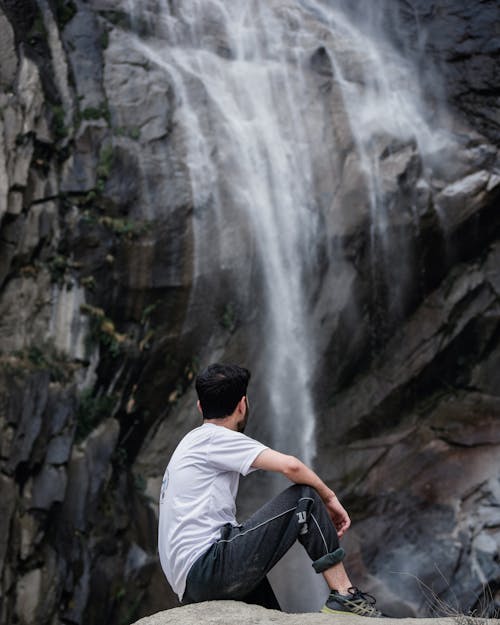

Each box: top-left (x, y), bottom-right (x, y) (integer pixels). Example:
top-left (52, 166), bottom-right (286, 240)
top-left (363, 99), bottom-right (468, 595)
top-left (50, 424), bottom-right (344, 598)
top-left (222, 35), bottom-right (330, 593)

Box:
top-left (158, 364), bottom-right (381, 616)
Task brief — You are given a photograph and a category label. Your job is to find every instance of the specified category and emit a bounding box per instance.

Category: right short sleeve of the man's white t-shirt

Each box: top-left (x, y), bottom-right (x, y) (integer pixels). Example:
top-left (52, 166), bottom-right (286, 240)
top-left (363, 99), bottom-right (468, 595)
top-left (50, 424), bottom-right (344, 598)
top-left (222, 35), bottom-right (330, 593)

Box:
top-left (208, 426), bottom-right (267, 475)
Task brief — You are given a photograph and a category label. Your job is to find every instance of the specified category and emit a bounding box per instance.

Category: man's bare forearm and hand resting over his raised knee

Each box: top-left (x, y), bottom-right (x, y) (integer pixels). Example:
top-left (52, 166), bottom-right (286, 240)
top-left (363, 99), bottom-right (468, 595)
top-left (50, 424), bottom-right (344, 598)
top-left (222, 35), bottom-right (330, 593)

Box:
top-left (252, 449), bottom-right (351, 538)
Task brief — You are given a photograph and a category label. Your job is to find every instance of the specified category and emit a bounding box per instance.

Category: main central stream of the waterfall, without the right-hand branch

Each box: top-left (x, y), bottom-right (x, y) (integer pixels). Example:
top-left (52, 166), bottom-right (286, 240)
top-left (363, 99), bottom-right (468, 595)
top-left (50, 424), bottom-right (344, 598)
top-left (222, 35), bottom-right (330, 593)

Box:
top-left (136, 2), bottom-right (328, 463)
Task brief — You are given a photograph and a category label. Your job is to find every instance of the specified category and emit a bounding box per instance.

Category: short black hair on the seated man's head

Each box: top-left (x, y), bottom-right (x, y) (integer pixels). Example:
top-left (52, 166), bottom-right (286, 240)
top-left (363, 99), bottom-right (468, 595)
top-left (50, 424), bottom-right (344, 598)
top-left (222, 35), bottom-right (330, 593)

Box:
top-left (196, 363), bottom-right (251, 419)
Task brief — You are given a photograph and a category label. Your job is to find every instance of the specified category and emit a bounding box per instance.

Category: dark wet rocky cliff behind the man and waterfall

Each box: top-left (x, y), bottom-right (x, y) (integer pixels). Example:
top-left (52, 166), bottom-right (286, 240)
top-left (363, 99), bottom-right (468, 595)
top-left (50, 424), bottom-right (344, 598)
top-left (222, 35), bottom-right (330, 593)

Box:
top-left (0, 0), bottom-right (500, 625)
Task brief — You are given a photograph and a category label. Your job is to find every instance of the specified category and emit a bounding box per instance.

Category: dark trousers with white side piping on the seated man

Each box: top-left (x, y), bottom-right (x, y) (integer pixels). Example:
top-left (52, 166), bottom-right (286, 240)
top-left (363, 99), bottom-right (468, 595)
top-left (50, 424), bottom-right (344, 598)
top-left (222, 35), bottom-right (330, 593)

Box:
top-left (183, 484), bottom-right (344, 608)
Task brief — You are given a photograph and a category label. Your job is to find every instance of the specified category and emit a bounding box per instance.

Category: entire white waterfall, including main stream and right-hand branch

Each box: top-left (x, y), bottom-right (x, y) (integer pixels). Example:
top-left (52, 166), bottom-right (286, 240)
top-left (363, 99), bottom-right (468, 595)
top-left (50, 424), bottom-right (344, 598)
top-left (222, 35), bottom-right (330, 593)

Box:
top-left (125, 0), bottom-right (454, 609)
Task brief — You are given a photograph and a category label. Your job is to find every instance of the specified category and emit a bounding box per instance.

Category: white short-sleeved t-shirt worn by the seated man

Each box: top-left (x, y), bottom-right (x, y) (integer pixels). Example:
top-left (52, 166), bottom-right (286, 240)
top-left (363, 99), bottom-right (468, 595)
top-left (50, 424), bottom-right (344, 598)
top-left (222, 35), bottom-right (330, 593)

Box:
top-left (158, 423), bottom-right (267, 601)
